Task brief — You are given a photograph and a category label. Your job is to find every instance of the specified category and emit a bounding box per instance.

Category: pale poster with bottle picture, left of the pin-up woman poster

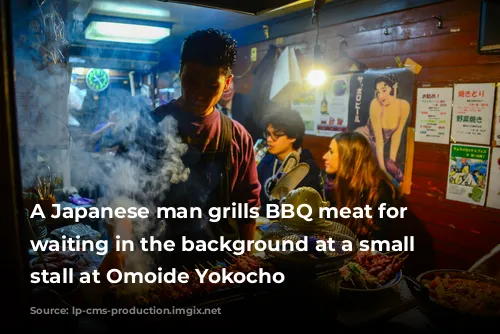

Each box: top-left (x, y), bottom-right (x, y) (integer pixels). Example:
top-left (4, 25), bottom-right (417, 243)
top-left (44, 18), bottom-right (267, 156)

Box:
top-left (315, 75), bottom-right (350, 137)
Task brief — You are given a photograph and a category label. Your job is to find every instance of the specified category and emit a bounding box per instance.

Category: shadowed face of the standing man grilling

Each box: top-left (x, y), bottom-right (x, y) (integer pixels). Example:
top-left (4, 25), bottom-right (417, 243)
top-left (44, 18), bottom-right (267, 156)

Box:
top-left (180, 62), bottom-right (233, 115)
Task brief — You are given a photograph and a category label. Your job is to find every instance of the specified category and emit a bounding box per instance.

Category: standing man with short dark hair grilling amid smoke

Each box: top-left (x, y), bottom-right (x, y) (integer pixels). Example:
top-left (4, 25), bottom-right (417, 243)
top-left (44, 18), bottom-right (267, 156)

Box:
top-left (101, 29), bottom-right (261, 272)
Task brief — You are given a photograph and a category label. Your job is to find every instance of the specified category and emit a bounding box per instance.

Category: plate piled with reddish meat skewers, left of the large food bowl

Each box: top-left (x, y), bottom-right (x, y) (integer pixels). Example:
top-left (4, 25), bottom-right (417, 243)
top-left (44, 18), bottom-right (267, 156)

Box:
top-left (340, 251), bottom-right (406, 292)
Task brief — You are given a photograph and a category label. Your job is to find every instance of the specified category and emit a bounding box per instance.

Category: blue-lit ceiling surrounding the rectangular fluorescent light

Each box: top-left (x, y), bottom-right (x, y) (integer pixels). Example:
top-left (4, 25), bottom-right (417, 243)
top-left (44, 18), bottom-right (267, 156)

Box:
top-left (69, 0), bottom-right (314, 71)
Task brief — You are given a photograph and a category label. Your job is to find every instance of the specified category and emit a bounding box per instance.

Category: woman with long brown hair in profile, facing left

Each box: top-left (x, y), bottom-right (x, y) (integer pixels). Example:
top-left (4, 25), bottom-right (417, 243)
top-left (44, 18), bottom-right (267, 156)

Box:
top-left (323, 132), bottom-right (401, 239)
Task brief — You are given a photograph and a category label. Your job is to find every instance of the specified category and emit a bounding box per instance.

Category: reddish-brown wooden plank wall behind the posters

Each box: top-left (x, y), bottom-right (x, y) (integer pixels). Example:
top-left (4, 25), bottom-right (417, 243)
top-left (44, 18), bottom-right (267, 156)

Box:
top-left (235, 0), bottom-right (500, 268)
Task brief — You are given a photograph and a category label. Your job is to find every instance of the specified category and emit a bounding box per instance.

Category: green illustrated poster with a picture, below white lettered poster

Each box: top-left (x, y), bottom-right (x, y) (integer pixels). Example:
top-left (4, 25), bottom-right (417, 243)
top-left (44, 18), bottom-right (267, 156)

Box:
top-left (446, 144), bottom-right (490, 205)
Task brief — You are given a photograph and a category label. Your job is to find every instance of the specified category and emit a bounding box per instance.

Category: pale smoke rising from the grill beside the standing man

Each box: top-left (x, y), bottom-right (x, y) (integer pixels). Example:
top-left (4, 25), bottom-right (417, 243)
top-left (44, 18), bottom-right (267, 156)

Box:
top-left (16, 57), bottom-right (189, 289)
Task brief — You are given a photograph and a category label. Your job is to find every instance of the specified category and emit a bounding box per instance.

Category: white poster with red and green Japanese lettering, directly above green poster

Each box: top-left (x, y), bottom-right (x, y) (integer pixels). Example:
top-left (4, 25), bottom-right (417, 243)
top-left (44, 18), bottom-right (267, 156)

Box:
top-left (451, 83), bottom-right (495, 145)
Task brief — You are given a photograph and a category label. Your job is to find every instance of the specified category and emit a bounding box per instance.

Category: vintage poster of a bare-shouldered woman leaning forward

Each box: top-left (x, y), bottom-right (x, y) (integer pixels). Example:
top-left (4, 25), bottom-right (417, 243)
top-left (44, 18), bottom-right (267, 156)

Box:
top-left (348, 68), bottom-right (414, 183)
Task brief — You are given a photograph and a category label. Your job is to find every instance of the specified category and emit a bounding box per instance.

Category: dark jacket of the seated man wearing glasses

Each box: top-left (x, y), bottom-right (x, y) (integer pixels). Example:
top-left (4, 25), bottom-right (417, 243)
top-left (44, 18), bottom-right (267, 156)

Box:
top-left (257, 149), bottom-right (321, 216)
